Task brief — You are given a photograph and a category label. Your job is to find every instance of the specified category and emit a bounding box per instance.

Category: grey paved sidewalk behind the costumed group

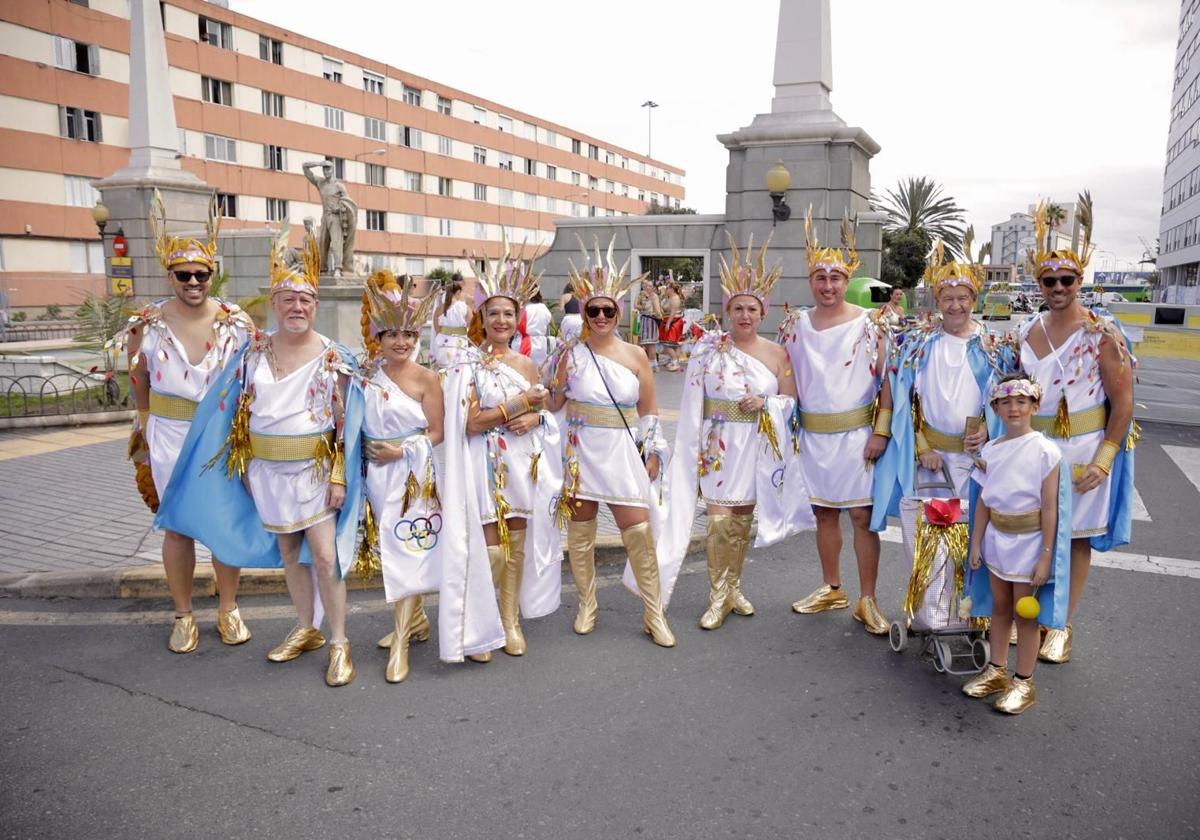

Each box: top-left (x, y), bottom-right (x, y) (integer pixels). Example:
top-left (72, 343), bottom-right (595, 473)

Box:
top-left (0, 373), bottom-right (704, 598)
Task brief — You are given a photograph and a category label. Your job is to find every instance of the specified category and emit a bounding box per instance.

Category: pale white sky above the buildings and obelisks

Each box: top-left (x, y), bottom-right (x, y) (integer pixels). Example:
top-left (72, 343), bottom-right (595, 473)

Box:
top-left (230, 0), bottom-right (1180, 269)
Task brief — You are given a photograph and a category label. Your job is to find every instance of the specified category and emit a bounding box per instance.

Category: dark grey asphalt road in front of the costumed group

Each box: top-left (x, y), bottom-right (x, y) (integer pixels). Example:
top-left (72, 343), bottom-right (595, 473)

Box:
top-left (0, 535), bottom-right (1200, 840)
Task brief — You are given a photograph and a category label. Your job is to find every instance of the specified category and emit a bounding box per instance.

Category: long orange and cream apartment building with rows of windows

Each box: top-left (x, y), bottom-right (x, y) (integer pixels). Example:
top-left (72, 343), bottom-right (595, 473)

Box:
top-left (0, 0), bottom-right (684, 307)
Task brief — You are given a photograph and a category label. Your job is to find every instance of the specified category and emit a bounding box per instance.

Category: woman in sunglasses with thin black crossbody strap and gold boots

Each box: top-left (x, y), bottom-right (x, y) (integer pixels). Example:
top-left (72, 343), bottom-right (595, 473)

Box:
top-left (547, 244), bottom-right (674, 647)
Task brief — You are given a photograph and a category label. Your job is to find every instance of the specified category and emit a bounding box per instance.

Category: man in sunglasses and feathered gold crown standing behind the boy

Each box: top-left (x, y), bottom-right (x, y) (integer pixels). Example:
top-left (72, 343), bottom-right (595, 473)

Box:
top-left (1019, 192), bottom-right (1138, 662)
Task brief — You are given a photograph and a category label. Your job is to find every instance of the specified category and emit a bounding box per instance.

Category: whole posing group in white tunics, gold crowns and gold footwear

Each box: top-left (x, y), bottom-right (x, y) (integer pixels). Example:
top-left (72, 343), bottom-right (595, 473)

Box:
top-left (126, 184), bottom-right (1136, 714)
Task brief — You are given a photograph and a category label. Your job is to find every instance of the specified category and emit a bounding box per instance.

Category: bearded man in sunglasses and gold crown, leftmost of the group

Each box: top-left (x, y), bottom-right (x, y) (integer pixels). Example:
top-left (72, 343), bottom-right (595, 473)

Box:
top-left (110, 191), bottom-right (254, 653)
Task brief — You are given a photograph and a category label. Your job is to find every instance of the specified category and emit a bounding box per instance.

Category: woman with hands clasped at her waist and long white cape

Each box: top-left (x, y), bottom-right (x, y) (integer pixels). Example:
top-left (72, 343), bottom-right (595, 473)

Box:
top-left (439, 241), bottom-right (562, 661)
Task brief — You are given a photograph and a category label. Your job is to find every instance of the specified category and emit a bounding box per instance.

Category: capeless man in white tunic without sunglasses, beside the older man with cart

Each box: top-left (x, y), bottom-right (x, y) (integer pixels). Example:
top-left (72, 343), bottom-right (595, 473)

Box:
top-left (779, 208), bottom-right (892, 635)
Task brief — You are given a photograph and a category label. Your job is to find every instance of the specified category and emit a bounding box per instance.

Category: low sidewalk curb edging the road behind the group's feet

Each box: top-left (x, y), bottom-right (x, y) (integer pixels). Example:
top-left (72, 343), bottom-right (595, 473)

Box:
top-left (0, 534), bottom-right (706, 599)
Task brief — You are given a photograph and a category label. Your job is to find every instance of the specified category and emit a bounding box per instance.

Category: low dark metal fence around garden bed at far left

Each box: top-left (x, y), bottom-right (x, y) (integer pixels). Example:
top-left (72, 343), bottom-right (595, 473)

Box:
top-left (0, 372), bottom-right (133, 418)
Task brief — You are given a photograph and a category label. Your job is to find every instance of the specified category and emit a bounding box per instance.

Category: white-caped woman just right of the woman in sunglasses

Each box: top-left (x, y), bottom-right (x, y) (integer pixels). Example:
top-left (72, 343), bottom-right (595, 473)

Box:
top-left (660, 238), bottom-right (816, 630)
